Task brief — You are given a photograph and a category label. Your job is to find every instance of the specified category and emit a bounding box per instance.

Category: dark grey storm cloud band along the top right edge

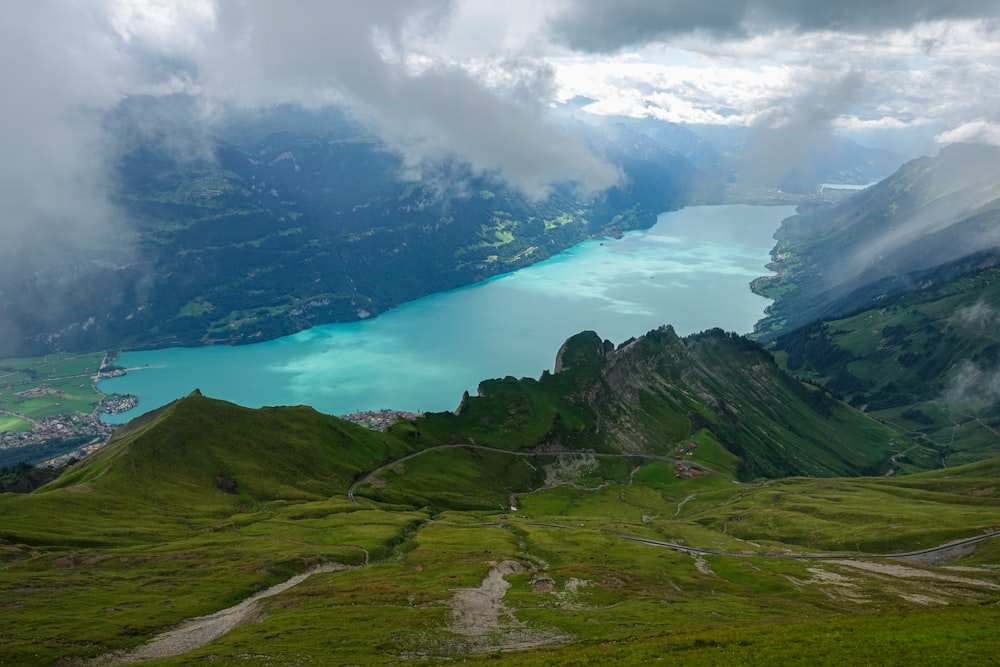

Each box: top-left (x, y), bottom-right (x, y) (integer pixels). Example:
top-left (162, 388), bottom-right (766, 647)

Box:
top-left (550, 0), bottom-right (1000, 52)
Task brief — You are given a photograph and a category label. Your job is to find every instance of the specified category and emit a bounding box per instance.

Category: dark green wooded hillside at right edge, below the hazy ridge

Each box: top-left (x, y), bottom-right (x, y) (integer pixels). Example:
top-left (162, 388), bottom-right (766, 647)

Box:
top-left (773, 268), bottom-right (1000, 470)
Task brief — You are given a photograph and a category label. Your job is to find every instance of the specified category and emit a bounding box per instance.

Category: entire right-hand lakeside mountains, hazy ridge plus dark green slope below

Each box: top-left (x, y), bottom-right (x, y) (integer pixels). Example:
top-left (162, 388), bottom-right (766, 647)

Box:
top-left (755, 144), bottom-right (1000, 470)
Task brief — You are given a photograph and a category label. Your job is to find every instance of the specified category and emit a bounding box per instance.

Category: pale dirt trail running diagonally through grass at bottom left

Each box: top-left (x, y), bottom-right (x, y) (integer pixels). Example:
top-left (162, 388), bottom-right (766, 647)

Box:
top-left (87, 563), bottom-right (351, 667)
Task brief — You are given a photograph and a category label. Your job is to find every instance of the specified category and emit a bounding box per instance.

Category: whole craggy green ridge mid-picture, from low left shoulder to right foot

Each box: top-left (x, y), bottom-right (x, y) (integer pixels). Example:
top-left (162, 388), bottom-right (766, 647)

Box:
top-left (388, 327), bottom-right (909, 488)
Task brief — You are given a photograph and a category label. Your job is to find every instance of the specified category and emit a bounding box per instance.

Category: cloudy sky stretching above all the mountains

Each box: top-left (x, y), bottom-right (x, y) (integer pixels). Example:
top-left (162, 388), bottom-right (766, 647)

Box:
top-left (0, 0), bottom-right (1000, 276)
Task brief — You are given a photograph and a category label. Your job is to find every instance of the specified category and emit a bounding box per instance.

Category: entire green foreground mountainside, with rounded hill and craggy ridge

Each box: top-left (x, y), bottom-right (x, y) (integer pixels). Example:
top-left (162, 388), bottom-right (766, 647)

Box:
top-left (0, 340), bottom-right (1000, 666)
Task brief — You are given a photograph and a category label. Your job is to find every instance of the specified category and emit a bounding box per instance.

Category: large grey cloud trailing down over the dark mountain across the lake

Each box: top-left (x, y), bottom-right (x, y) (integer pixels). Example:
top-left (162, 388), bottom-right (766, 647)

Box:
top-left (189, 1), bottom-right (618, 197)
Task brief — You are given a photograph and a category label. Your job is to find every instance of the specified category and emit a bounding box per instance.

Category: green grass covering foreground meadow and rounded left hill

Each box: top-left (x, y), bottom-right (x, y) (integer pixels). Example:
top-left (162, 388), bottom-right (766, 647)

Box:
top-left (0, 395), bottom-right (1000, 665)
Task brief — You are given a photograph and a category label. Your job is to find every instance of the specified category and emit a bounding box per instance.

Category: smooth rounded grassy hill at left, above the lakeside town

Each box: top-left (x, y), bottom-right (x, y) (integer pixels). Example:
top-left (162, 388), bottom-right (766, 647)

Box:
top-left (0, 393), bottom-right (407, 546)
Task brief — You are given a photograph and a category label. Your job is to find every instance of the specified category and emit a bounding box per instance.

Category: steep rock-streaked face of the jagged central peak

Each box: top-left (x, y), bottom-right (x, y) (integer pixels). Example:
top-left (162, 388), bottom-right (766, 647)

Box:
top-left (555, 326), bottom-right (891, 477)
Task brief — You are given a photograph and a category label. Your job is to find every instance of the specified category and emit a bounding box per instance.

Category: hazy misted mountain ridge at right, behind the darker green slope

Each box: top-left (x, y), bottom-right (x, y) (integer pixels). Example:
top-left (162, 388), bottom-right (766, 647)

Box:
top-left (754, 144), bottom-right (1000, 340)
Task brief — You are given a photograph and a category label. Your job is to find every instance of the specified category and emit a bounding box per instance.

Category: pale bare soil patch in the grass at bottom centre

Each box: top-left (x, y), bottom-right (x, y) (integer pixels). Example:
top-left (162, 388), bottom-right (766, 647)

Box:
top-left (448, 560), bottom-right (565, 653)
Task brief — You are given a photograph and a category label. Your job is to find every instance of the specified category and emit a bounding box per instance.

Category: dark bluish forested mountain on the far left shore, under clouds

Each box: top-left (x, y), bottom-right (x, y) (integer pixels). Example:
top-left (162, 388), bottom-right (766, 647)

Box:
top-left (0, 96), bottom-right (698, 356)
